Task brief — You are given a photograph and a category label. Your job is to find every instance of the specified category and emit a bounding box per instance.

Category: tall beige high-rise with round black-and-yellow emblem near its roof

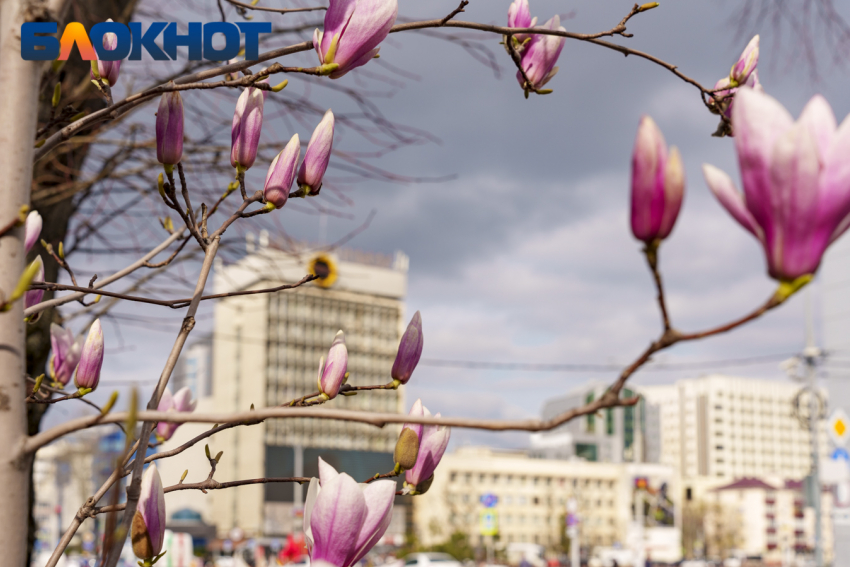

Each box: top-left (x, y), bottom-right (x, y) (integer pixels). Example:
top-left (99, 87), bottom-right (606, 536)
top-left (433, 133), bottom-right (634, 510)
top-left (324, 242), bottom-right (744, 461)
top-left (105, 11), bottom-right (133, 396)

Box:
top-left (160, 234), bottom-right (408, 537)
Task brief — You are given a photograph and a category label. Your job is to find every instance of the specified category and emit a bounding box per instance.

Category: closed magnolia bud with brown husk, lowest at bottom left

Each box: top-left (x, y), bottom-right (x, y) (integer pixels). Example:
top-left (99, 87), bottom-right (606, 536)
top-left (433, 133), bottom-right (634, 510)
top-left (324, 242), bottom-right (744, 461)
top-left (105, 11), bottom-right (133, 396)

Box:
top-left (130, 463), bottom-right (165, 562)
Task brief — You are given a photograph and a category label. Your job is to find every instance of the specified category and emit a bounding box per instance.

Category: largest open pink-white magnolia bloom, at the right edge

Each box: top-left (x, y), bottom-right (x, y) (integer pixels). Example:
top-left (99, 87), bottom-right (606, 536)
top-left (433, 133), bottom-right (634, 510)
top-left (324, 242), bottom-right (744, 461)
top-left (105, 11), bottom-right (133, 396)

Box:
top-left (703, 89), bottom-right (850, 282)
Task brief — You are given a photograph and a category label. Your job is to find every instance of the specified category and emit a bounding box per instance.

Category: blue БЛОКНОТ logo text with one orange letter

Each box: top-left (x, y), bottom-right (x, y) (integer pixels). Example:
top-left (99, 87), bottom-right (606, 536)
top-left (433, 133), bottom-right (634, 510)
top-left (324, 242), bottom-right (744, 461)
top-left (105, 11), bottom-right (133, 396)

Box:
top-left (21, 22), bottom-right (272, 61)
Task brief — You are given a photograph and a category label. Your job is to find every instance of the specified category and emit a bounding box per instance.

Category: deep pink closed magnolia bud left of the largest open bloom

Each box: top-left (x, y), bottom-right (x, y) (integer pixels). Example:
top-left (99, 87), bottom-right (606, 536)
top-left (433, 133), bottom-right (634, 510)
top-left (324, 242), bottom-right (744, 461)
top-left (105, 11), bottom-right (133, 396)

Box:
top-left (632, 116), bottom-right (685, 244)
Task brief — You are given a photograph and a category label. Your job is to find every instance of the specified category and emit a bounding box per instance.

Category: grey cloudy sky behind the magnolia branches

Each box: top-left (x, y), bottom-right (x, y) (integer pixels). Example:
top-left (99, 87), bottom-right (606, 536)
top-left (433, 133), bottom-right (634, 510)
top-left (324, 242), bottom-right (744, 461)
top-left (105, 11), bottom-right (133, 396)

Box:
top-left (43, 0), bottom-right (850, 452)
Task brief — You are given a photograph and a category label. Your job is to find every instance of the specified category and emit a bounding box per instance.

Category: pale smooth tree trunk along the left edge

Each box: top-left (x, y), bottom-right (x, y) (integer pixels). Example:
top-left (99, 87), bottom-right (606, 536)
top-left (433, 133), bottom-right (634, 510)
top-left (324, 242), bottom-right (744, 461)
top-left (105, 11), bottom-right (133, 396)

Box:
top-left (0, 0), bottom-right (49, 567)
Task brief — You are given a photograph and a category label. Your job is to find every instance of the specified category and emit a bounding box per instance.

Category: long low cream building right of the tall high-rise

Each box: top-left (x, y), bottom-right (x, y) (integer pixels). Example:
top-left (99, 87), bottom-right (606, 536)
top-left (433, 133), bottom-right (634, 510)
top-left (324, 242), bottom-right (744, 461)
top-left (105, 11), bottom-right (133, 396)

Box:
top-left (413, 447), bottom-right (681, 562)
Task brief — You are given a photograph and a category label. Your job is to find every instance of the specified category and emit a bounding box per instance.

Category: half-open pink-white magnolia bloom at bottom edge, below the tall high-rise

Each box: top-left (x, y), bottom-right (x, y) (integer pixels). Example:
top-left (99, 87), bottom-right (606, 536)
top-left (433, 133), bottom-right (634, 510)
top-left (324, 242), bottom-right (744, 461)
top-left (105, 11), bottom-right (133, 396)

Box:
top-left (304, 458), bottom-right (396, 567)
